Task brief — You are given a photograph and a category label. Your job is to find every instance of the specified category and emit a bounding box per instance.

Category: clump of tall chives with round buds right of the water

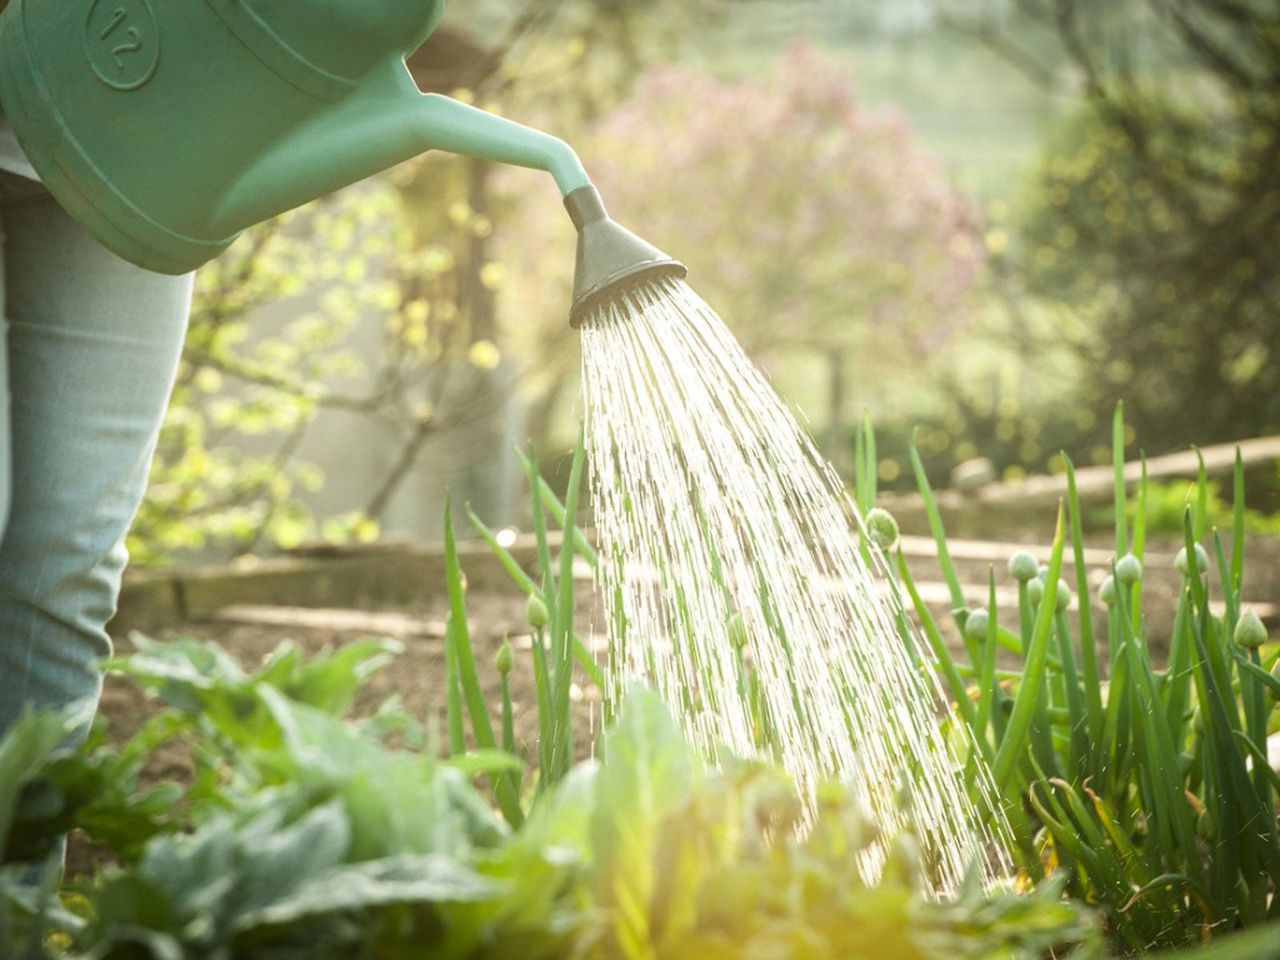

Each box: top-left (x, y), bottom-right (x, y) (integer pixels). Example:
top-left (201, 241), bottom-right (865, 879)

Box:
top-left (858, 408), bottom-right (1280, 950)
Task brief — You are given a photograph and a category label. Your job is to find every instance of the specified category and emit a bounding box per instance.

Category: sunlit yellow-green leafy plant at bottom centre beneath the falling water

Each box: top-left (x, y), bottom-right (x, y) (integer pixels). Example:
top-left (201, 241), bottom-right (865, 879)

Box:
top-left (581, 690), bottom-right (1097, 960)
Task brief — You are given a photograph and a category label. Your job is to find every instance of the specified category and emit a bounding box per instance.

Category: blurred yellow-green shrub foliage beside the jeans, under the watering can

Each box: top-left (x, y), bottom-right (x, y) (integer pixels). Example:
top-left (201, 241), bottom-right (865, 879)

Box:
top-left (129, 198), bottom-right (386, 562)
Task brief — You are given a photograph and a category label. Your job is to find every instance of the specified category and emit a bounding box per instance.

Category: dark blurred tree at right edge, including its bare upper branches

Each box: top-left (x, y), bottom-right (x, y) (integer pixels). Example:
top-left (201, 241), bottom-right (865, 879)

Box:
top-left (952, 0), bottom-right (1280, 448)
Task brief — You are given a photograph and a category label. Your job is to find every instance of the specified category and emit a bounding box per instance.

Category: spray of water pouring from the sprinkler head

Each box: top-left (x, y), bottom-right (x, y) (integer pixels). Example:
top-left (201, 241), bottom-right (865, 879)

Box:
top-left (582, 273), bottom-right (1002, 890)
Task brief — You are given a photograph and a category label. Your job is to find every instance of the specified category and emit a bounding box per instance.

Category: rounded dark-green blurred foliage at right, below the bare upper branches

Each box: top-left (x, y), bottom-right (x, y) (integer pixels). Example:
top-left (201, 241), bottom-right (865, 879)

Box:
top-left (1018, 96), bottom-right (1280, 447)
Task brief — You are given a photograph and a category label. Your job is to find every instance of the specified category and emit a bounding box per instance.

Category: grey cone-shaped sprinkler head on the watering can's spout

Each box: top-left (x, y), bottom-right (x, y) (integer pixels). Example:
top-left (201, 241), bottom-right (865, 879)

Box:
top-left (564, 186), bottom-right (687, 328)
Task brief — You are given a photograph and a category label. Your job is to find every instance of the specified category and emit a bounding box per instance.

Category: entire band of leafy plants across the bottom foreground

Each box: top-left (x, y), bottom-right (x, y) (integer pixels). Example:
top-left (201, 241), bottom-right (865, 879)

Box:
top-left (0, 644), bottom-right (1098, 960)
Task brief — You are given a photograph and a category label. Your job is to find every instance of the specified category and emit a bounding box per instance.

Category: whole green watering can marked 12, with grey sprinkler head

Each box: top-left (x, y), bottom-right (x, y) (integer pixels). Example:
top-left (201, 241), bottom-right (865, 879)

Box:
top-left (0, 0), bottom-right (685, 324)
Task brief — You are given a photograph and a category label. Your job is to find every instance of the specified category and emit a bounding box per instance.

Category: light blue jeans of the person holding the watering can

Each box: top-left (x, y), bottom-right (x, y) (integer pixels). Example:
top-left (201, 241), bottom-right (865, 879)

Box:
top-left (0, 173), bottom-right (191, 736)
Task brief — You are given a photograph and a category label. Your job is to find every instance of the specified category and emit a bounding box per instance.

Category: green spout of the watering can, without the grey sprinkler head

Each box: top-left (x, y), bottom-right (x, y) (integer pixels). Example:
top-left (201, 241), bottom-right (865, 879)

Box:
top-left (215, 61), bottom-right (590, 233)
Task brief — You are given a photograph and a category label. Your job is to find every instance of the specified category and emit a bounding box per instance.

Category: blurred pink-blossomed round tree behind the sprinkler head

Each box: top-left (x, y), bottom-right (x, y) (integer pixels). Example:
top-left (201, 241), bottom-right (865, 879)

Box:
top-left (499, 45), bottom-right (983, 460)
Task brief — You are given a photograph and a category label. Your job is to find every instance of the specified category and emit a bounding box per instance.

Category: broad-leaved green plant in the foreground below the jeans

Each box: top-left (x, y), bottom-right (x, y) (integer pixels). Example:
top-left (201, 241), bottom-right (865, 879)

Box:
top-left (0, 637), bottom-right (586, 957)
